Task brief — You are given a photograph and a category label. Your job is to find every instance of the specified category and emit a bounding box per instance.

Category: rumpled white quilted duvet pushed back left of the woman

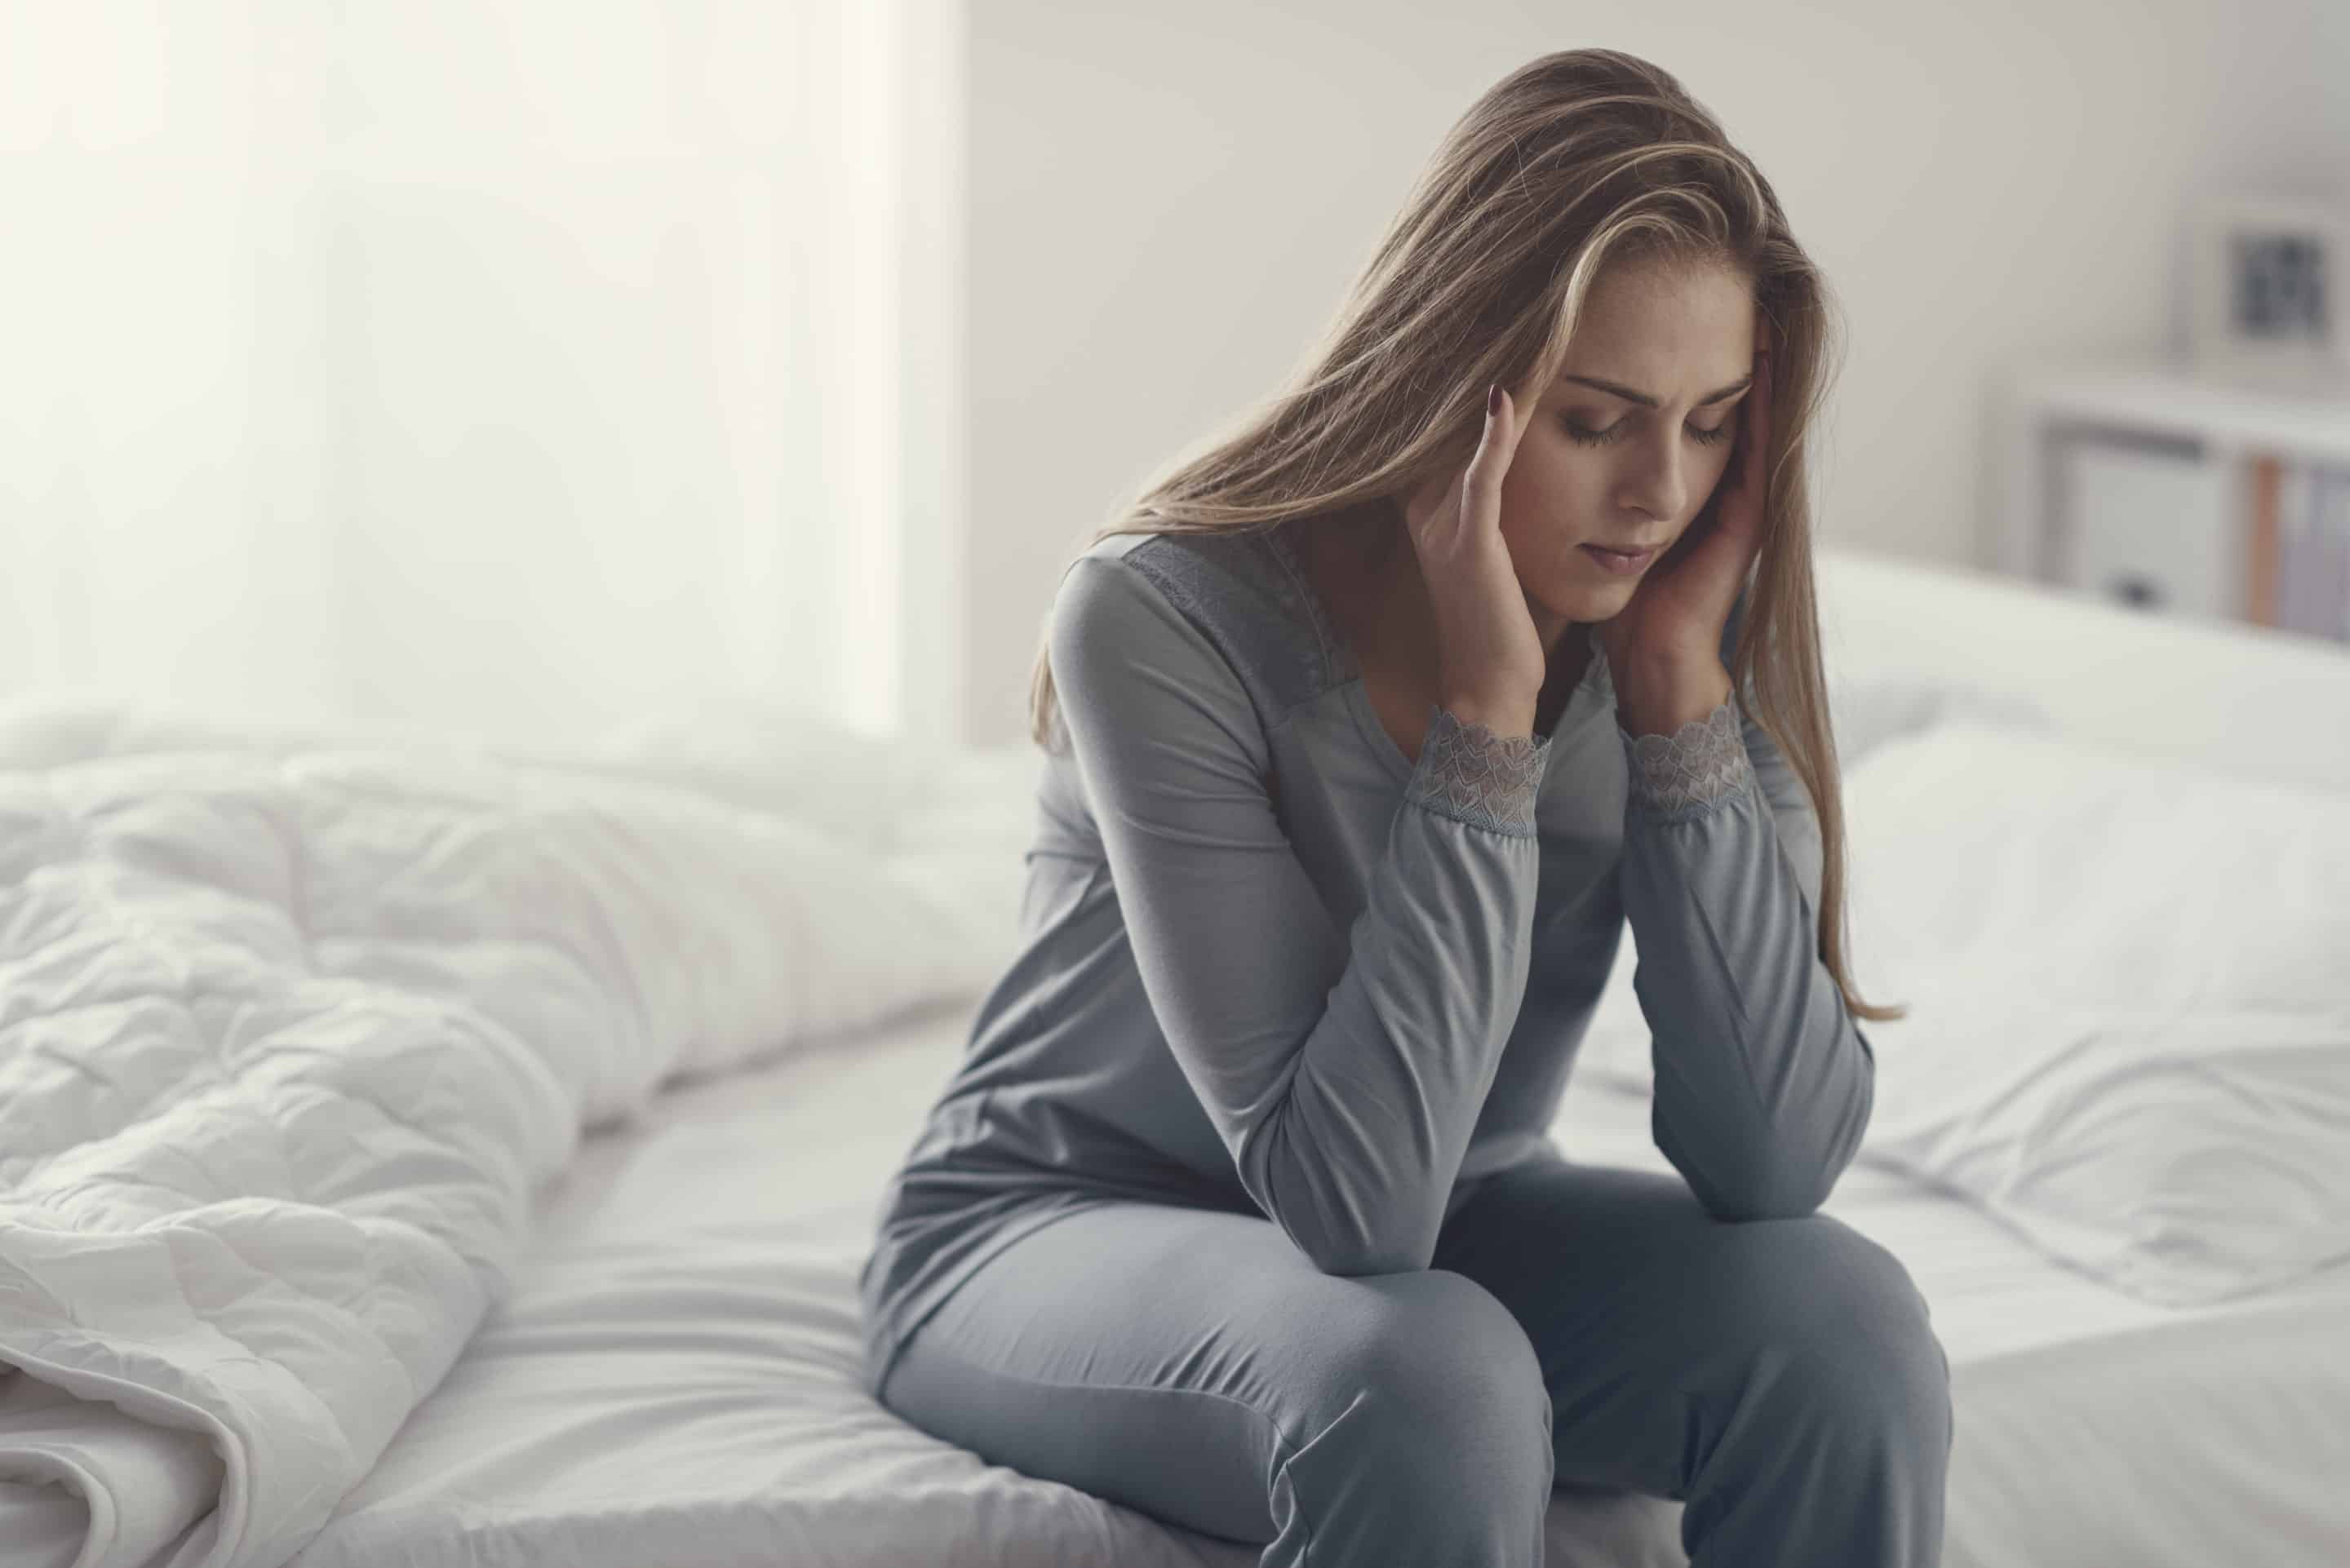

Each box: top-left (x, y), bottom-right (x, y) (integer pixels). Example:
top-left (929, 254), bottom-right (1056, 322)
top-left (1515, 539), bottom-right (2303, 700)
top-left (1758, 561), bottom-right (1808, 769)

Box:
top-left (0, 705), bottom-right (1020, 1568)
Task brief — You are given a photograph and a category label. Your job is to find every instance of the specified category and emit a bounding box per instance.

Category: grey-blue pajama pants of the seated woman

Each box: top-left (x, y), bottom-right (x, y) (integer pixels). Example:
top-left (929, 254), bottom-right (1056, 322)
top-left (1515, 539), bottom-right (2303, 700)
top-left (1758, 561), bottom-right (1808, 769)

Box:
top-left (881, 1159), bottom-right (1955, 1568)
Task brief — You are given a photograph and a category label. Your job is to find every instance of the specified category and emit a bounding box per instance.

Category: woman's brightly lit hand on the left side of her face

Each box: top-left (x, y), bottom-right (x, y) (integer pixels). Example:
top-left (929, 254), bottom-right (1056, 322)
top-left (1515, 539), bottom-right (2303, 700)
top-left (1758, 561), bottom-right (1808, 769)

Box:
top-left (1403, 386), bottom-right (1549, 736)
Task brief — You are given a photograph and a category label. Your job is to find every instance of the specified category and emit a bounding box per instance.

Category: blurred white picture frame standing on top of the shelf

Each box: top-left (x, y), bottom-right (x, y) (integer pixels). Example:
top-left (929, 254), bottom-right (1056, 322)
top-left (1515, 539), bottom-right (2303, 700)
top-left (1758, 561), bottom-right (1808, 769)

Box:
top-left (2188, 195), bottom-right (2350, 392)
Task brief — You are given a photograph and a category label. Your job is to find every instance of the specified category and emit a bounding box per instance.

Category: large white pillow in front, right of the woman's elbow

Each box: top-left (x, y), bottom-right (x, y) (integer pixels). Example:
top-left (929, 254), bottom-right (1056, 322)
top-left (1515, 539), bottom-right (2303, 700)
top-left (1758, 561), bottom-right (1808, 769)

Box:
top-left (1576, 720), bottom-right (2350, 1304)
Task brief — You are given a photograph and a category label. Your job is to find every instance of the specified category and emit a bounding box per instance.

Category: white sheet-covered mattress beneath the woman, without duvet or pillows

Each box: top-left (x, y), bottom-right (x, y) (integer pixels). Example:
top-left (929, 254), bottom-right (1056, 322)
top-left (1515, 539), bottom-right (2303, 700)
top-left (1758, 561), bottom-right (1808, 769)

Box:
top-left (274, 1006), bottom-right (2350, 1568)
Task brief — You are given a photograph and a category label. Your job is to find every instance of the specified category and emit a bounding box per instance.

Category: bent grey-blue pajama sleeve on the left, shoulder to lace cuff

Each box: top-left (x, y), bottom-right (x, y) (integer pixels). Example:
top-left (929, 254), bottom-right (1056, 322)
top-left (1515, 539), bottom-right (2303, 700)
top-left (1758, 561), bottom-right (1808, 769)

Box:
top-left (1048, 557), bottom-right (1549, 1274)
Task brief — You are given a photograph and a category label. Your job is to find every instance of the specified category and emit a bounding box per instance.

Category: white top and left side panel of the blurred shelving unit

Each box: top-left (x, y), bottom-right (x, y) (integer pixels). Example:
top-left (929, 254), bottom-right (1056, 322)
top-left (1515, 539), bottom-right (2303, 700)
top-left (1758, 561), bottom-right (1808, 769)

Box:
top-left (1995, 362), bottom-right (2350, 635)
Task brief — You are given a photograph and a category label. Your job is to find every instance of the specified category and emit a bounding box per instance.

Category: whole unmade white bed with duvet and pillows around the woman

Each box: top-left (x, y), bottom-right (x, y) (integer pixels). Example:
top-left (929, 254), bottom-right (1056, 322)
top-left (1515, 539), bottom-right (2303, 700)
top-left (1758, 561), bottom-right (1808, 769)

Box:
top-left (0, 552), bottom-right (2350, 1568)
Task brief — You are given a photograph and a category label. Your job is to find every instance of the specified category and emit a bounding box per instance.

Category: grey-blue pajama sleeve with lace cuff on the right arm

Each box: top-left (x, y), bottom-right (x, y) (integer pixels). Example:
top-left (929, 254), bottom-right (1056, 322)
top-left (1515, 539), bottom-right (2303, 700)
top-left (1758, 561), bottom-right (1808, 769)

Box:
top-left (1616, 582), bottom-right (1875, 1220)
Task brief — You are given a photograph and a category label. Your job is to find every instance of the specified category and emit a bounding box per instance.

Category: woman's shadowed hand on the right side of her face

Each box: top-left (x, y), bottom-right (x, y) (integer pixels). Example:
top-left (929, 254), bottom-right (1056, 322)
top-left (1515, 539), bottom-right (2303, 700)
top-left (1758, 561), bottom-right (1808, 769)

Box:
top-left (1594, 352), bottom-right (1770, 689)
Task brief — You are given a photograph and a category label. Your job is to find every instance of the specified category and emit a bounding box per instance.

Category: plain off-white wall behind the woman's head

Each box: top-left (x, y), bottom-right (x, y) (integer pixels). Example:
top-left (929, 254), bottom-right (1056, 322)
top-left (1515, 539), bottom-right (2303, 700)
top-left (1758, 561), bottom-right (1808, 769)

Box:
top-left (966, 0), bottom-right (2350, 743)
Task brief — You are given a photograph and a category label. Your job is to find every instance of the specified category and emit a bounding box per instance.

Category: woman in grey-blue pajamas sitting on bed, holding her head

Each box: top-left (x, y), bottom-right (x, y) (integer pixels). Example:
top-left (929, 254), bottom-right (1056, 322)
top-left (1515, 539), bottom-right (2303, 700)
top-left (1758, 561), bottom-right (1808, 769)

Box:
top-left (862, 50), bottom-right (1953, 1568)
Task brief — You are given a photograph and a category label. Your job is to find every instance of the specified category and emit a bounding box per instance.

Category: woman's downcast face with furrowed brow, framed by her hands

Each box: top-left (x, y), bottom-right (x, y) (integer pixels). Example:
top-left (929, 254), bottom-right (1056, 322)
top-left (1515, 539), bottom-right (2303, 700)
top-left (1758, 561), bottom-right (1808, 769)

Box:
top-left (1501, 266), bottom-right (1755, 644)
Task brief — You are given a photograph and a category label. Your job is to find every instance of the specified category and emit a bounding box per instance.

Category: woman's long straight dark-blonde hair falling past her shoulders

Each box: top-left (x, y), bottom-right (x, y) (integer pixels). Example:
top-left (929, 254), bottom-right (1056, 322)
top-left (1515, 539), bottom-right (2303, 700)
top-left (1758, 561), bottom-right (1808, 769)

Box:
top-left (1029, 50), bottom-right (1909, 1021)
